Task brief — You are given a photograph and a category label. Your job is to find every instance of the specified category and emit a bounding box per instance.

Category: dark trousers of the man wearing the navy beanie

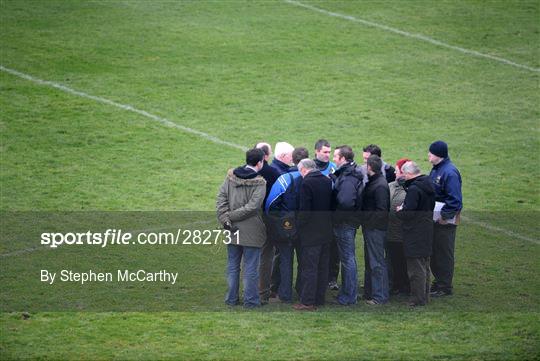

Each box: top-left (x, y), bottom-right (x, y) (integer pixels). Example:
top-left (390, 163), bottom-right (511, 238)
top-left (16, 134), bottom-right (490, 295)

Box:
top-left (431, 223), bottom-right (457, 293)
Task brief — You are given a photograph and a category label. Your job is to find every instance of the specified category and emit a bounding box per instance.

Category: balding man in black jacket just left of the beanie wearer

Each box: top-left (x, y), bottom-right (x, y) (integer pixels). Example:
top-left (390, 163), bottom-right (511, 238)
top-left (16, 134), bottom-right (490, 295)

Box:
top-left (397, 162), bottom-right (435, 307)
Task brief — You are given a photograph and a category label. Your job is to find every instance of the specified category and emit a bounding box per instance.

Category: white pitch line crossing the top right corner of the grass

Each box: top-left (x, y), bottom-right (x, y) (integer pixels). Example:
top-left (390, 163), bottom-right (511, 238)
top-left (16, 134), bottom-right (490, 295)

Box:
top-left (284, 0), bottom-right (540, 72)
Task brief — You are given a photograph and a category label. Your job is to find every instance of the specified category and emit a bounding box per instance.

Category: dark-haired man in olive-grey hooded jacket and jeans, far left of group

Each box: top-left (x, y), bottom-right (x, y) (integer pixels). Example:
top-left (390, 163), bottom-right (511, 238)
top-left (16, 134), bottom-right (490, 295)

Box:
top-left (216, 149), bottom-right (266, 308)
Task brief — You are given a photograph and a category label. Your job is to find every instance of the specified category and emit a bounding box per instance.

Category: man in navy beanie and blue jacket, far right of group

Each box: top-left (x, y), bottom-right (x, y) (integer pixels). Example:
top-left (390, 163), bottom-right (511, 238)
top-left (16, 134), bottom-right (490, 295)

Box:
top-left (428, 140), bottom-right (463, 297)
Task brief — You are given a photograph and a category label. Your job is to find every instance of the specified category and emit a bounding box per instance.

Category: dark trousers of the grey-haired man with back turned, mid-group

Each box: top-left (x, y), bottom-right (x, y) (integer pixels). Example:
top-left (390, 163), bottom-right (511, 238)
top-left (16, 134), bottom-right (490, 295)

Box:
top-left (300, 244), bottom-right (330, 306)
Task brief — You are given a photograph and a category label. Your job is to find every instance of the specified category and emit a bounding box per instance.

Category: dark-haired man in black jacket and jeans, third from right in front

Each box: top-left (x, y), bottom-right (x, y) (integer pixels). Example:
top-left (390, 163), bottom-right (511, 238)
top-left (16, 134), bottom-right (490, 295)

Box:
top-left (361, 154), bottom-right (390, 305)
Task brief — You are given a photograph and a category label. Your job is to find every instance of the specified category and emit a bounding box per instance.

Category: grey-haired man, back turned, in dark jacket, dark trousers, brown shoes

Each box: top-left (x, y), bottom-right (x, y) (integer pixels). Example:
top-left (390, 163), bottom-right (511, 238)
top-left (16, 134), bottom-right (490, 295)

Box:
top-left (293, 159), bottom-right (332, 311)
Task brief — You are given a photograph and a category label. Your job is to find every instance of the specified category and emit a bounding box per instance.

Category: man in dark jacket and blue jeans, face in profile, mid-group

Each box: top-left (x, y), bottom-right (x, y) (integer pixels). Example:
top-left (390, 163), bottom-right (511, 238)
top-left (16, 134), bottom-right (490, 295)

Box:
top-left (330, 145), bottom-right (364, 305)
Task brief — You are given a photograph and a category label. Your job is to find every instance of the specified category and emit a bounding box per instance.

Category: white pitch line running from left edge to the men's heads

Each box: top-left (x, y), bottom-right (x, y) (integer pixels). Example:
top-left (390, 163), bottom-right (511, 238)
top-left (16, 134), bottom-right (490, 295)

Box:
top-left (0, 65), bottom-right (248, 151)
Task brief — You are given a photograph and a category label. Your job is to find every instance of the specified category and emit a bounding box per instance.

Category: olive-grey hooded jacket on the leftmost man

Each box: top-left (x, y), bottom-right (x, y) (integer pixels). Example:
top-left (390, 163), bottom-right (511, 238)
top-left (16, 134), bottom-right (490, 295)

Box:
top-left (216, 167), bottom-right (266, 248)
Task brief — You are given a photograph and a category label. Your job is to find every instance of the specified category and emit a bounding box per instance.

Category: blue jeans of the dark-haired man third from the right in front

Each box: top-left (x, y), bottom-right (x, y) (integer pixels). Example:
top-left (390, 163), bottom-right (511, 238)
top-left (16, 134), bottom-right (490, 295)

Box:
top-left (362, 228), bottom-right (389, 304)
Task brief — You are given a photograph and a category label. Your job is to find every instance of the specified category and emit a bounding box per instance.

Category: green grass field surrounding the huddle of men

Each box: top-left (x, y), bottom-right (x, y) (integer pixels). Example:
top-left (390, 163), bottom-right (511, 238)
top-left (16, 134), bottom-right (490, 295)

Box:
top-left (0, 0), bottom-right (540, 360)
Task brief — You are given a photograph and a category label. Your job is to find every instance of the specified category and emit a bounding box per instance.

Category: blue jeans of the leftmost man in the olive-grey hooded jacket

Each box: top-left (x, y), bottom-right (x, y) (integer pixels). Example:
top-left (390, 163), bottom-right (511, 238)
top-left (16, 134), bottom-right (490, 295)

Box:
top-left (225, 244), bottom-right (261, 307)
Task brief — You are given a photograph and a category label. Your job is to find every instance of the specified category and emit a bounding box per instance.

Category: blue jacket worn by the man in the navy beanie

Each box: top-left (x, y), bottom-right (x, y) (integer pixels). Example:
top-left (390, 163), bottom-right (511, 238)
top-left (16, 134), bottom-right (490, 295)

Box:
top-left (429, 158), bottom-right (463, 219)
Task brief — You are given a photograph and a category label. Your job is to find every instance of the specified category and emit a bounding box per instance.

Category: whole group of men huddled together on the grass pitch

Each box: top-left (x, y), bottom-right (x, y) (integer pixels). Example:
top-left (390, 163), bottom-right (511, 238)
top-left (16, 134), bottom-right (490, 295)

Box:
top-left (216, 139), bottom-right (462, 310)
